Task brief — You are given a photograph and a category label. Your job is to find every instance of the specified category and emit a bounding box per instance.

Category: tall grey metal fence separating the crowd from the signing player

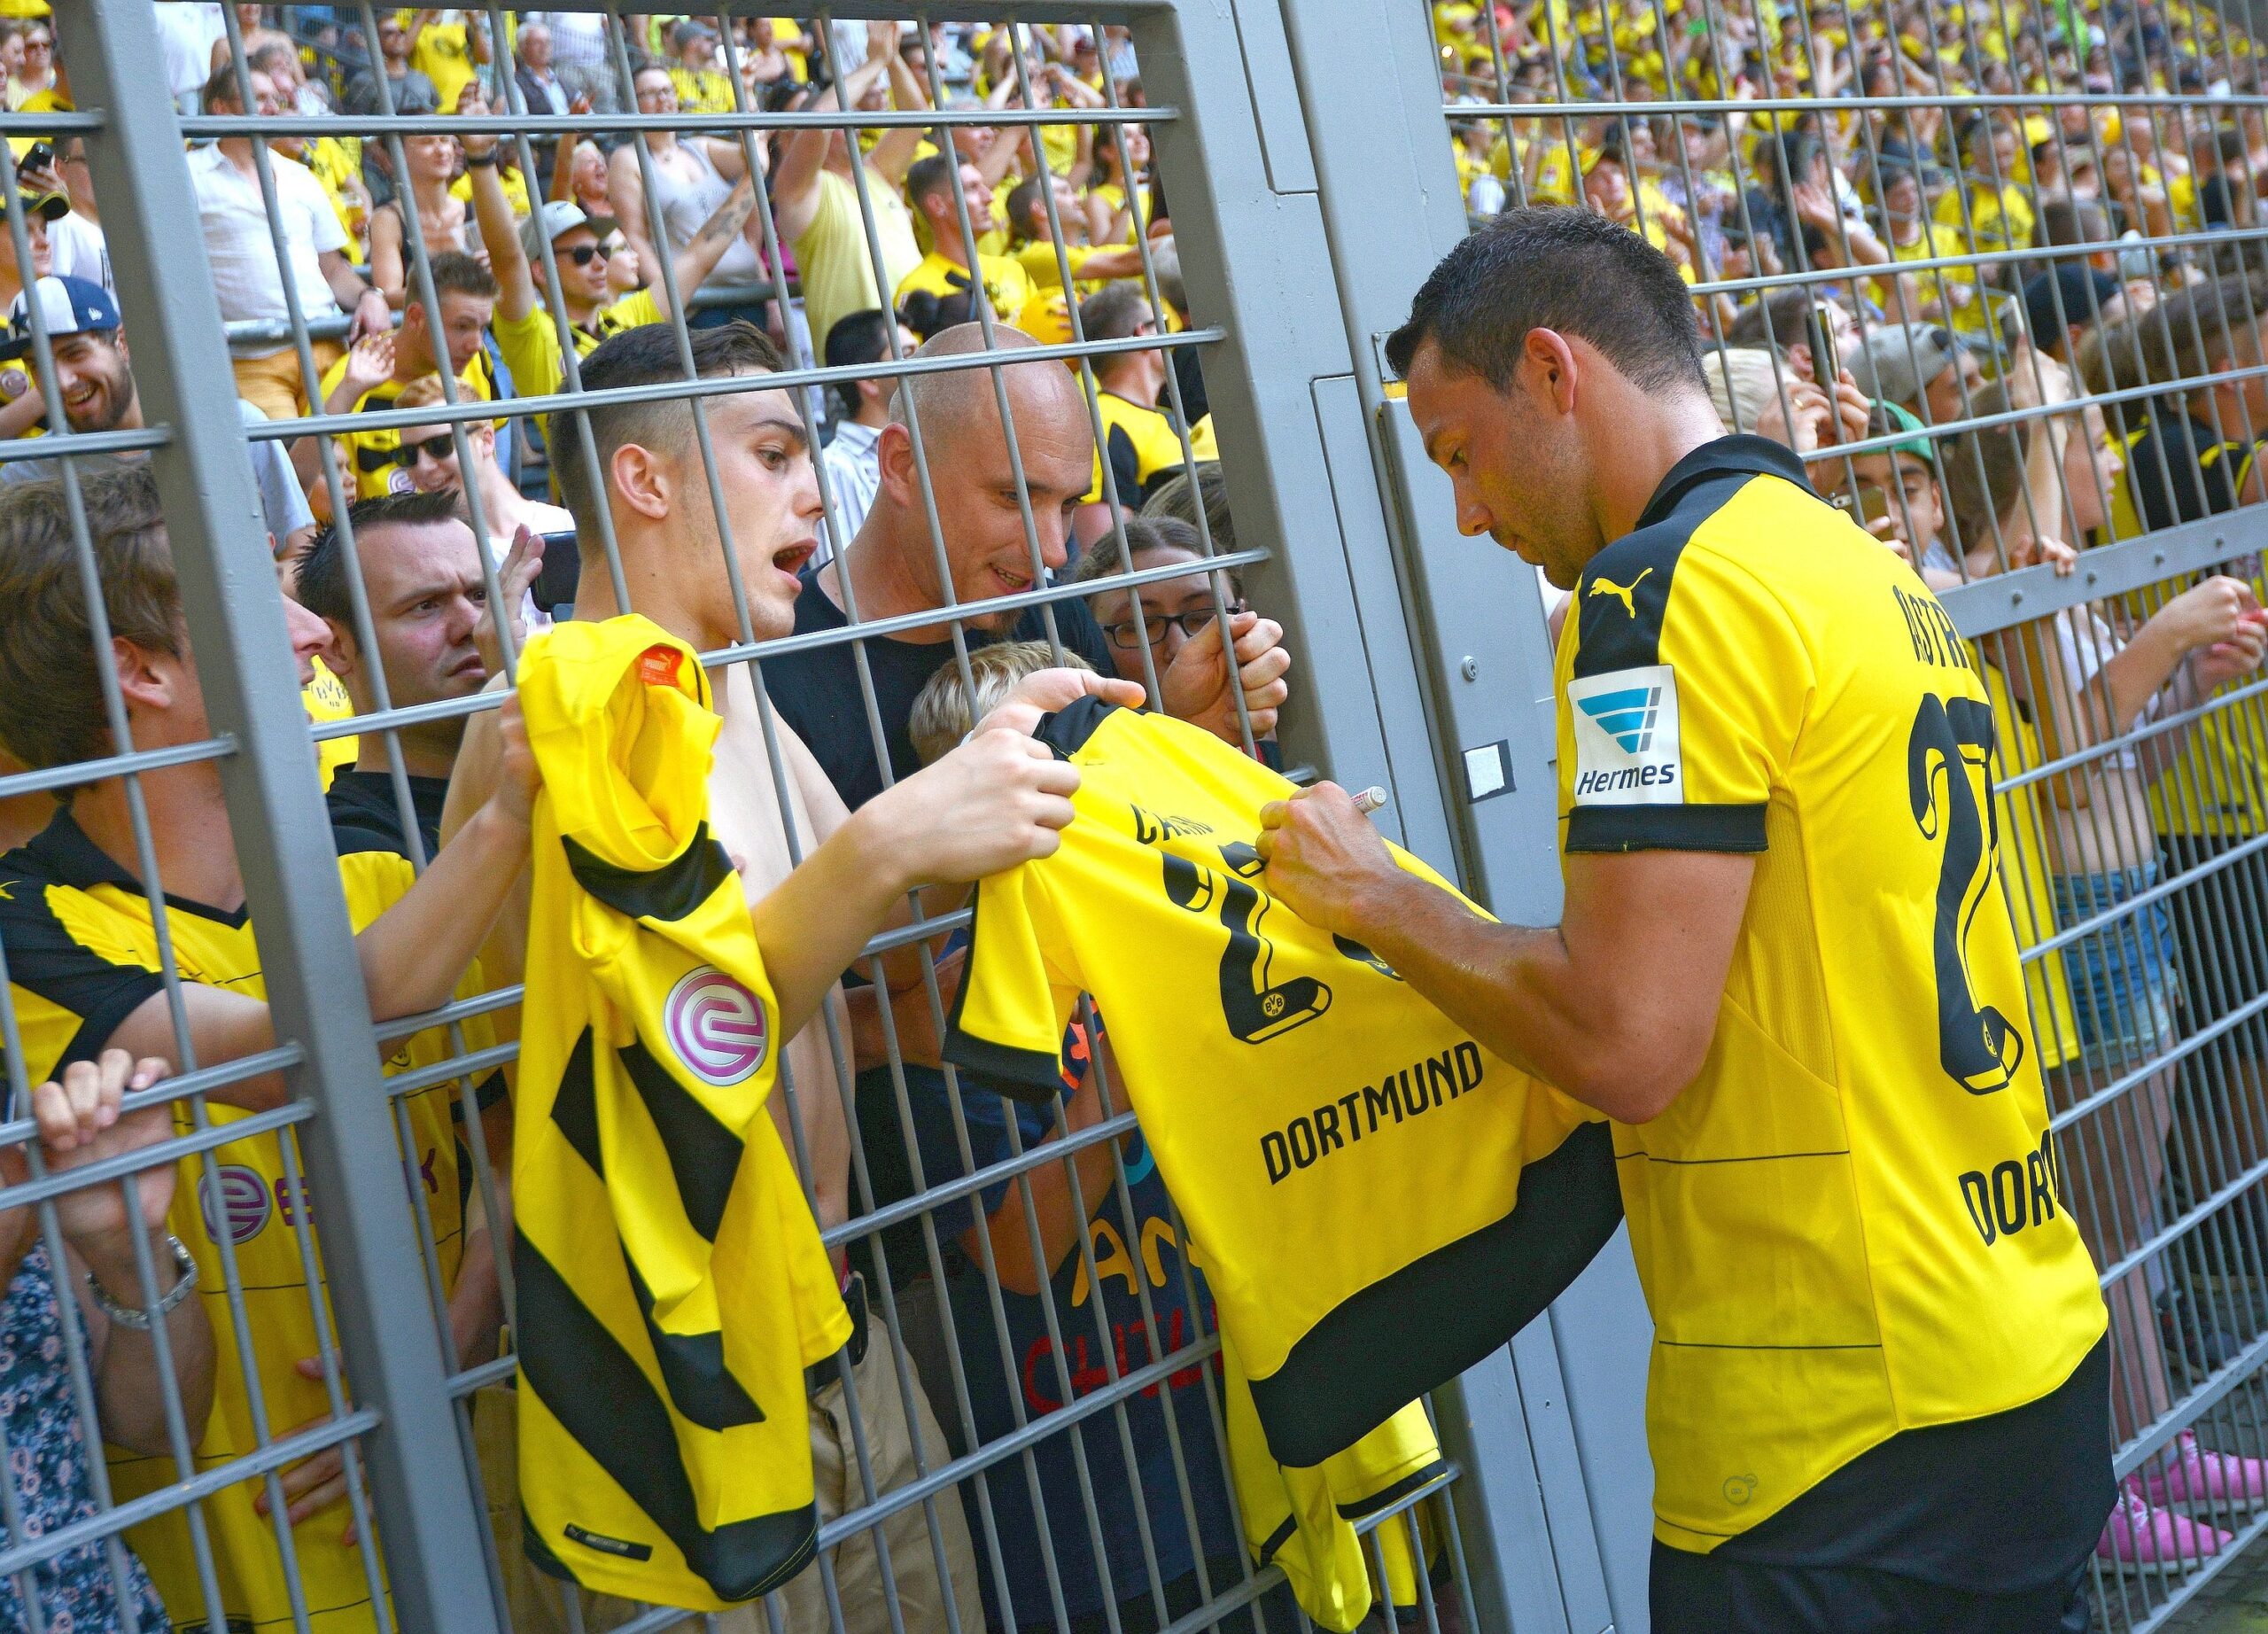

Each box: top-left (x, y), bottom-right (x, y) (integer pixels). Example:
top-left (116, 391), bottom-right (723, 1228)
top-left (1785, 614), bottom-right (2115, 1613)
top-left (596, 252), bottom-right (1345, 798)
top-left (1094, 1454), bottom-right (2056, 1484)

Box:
top-left (0, 0), bottom-right (2268, 1634)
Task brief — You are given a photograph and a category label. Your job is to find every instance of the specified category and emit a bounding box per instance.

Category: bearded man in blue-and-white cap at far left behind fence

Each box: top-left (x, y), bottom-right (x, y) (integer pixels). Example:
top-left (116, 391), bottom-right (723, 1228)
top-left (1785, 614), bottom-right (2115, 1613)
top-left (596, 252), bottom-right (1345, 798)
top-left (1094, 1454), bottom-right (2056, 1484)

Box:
top-left (0, 276), bottom-right (315, 549)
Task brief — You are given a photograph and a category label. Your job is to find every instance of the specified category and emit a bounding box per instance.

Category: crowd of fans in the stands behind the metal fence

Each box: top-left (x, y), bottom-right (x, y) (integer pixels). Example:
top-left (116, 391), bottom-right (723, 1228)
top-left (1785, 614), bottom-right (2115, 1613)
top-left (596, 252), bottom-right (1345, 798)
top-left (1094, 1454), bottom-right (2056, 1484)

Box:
top-left (0, 0), bottom-right (2268, 1634)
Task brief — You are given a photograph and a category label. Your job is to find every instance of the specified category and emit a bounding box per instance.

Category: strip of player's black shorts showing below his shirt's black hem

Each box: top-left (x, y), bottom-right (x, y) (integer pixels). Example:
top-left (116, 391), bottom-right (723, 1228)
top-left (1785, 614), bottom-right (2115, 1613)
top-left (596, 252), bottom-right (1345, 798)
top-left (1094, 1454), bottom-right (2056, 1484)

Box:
top-left (1651, 1544), bottom-right (2093, 1634)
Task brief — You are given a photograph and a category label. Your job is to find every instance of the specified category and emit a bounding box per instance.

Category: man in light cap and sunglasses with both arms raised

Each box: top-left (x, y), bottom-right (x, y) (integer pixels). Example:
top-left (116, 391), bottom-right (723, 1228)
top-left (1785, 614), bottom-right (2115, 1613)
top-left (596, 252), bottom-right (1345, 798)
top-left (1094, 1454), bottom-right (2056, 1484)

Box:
top-left (461, 105), bottom-right (755, 415)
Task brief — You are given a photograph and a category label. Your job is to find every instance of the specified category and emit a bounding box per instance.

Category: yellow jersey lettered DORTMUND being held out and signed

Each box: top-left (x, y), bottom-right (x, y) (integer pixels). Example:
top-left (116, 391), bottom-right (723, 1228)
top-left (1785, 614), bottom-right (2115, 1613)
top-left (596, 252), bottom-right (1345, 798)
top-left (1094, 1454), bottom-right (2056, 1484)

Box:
top-left (946, 699), bottom-right (1615, 1468)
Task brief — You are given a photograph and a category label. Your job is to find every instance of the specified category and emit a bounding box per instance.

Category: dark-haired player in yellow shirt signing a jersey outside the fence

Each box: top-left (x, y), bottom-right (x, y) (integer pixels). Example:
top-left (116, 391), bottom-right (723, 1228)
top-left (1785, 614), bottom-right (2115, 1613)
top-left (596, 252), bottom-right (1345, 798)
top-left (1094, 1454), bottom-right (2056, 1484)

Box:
top-left (1263, 211), bottom-right (2114, 1634)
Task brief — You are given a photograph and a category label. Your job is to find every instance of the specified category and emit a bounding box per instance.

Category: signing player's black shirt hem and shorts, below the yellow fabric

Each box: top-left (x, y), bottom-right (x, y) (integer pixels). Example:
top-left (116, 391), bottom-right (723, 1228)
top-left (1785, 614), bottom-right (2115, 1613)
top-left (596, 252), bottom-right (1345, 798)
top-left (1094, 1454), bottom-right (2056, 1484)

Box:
top-left (1649, 1339), bottom-right (2118, 1634)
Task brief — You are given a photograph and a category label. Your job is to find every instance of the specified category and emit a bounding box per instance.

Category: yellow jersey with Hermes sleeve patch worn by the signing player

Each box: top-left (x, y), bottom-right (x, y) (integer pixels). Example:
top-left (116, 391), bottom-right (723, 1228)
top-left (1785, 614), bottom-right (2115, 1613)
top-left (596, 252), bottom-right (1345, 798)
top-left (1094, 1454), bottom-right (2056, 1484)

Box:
top-left (1560, 436), bottom-right (2107, 1552)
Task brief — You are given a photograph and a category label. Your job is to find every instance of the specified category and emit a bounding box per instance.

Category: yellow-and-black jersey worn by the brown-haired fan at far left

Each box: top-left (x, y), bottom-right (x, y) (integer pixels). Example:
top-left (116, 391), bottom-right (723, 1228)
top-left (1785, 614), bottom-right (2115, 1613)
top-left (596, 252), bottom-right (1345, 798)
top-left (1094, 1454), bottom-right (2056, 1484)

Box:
top-left (0, 810), bottom-right (493, 1634)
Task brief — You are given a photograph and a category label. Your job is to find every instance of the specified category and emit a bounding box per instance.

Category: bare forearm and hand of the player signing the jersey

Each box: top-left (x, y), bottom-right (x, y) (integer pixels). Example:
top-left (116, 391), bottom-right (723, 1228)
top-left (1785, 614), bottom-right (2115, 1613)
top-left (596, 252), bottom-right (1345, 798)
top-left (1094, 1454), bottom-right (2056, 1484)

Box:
top-left (1259, 783), bottom-right (1755, 1124)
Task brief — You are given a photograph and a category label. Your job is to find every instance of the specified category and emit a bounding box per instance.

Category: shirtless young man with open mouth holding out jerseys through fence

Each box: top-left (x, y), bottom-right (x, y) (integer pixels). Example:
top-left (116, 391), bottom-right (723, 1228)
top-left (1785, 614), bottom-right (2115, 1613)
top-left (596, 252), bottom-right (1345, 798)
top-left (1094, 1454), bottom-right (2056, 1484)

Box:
top-left (445, 323), bottom-right (1122, 1634)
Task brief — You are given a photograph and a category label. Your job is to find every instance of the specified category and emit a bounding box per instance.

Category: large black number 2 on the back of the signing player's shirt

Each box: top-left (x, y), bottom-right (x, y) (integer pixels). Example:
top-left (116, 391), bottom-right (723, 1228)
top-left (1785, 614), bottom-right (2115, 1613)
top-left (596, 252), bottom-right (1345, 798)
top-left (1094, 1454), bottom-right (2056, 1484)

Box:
top-left (1905, 695), bottom-right (2023, 1093)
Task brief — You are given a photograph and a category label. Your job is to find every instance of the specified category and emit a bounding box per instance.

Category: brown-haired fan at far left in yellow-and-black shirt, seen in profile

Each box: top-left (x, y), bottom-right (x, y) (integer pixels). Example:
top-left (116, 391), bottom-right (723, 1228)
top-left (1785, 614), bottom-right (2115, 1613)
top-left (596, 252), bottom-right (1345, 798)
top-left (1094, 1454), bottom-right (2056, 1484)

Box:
top-left (0, 470), bottom-right (533, 1634)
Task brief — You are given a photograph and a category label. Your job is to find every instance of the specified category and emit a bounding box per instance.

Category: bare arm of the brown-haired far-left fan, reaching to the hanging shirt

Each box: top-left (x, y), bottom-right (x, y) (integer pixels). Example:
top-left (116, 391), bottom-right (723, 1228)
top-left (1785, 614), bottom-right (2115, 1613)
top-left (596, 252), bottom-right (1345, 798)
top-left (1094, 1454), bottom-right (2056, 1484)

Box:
top-left (105, 704), bottom-right (535, 1109)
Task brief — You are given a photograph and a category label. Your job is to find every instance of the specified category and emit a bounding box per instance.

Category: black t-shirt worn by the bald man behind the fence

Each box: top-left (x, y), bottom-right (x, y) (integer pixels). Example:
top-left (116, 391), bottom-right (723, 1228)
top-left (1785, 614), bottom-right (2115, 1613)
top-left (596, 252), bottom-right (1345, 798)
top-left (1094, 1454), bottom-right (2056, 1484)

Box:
top-left (765, 574), bottom-right (1116, 810)
